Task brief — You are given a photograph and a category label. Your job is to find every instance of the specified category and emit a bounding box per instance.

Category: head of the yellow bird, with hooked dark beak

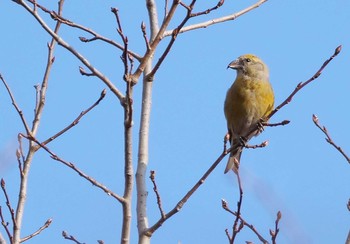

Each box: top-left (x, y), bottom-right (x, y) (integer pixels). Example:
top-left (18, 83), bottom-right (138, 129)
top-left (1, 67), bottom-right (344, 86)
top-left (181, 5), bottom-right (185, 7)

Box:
top-left (227, 54), bottom-right (269, 80)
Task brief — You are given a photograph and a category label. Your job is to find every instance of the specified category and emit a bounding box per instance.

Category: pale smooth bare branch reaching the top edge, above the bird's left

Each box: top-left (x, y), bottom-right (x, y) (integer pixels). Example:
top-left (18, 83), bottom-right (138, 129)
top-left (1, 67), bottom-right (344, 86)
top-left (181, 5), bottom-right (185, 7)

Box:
top-left (162, 0), bottom-right (267, 38)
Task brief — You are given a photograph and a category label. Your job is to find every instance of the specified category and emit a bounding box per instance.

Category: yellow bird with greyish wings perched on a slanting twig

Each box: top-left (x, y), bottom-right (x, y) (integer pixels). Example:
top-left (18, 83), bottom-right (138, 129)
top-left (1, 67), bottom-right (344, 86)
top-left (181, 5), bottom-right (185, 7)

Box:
top-left (224, 54), bottom-right (275, 173)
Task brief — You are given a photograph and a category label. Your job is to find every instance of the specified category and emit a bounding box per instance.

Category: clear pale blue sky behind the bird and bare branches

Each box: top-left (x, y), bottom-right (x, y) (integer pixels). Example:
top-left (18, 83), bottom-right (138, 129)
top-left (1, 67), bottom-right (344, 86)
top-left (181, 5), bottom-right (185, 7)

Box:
top-left (0, 0), bottom-right (350, 244)
